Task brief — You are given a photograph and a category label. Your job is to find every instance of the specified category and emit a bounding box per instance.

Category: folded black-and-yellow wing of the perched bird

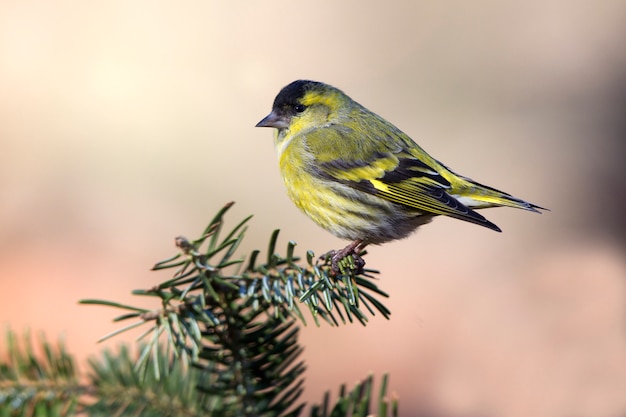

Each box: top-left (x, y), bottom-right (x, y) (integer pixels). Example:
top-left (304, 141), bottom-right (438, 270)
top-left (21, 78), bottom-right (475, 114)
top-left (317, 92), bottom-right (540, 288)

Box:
top-left (307, 128), bottom-right (500, 231)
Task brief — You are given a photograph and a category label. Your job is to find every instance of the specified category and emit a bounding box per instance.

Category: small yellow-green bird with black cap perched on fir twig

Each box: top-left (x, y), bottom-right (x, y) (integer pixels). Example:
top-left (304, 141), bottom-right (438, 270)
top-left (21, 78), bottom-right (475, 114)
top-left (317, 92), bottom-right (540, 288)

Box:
top-left (256, 80), bottom-right (546, 272)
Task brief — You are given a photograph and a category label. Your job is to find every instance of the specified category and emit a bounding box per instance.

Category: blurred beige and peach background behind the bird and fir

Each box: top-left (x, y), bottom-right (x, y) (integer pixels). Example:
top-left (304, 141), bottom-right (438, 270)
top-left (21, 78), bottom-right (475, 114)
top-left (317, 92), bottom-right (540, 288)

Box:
top-left (0, 0), bottom-right (626, 417)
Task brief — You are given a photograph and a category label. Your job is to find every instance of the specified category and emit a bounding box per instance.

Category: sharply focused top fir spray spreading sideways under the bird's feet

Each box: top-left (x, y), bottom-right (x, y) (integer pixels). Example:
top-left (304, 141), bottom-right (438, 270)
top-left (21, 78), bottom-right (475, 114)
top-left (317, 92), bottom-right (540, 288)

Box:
top-left (81, 203), bottom-right (390, 363)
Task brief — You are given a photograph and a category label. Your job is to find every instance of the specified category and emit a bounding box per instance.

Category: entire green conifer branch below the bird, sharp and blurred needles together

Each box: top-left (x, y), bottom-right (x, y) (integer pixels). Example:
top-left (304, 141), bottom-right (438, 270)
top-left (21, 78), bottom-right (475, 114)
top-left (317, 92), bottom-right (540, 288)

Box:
top-left (0, 203), bottom-right (397, 417)
